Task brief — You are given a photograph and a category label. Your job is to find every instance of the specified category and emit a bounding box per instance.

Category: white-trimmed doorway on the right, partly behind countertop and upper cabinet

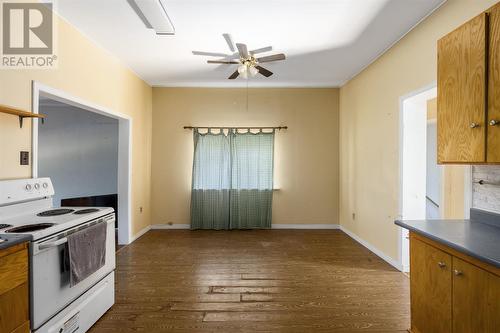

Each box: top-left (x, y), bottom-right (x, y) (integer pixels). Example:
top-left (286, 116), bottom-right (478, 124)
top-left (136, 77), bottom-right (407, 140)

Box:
top-left (399, 84), bottom-right (472, 272)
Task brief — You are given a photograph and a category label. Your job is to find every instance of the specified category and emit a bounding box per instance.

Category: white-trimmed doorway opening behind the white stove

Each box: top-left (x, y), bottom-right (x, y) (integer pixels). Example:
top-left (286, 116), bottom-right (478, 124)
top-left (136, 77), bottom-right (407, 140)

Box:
top-left (32, 82), bottom-right (131, 245)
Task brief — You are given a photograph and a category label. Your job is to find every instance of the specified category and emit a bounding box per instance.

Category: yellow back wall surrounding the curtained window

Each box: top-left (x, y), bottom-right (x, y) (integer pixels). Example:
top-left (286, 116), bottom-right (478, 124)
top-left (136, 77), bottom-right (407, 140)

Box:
top-left (152, 88), bottom-right (338, 224)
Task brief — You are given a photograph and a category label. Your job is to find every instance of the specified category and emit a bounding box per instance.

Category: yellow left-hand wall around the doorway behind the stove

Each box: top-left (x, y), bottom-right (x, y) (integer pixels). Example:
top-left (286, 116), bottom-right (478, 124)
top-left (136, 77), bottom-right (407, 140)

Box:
top-left (0, 19), bottom-right (152, 234)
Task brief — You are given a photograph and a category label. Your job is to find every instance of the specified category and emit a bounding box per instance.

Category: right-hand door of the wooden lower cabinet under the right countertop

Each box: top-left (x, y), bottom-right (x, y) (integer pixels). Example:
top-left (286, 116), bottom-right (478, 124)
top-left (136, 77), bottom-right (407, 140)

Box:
top-left (452, 258), bottom-right (500, 333)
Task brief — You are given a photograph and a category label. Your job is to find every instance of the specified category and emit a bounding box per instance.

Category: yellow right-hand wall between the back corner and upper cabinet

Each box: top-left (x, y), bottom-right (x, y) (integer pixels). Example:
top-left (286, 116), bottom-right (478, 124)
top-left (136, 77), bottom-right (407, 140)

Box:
top-left (340, 0), bottom-right (498, 260)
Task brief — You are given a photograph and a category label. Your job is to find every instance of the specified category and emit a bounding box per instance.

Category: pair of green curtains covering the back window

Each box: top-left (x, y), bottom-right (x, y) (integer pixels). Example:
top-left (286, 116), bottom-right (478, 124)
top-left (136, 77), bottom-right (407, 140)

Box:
top-left (191, 129), bottom-right (274, 230)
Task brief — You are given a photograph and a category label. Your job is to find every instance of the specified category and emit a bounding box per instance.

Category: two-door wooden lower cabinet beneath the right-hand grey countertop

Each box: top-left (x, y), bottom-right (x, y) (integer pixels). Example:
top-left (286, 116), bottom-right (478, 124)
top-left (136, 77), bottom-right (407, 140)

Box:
top-left (410, 232), bottom-right (500, 333)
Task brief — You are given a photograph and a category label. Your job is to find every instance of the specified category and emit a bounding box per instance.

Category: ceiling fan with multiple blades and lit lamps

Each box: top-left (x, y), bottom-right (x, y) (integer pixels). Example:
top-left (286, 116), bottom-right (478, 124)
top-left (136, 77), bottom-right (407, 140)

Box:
top-left (193, 34), bottom-right (285, 80)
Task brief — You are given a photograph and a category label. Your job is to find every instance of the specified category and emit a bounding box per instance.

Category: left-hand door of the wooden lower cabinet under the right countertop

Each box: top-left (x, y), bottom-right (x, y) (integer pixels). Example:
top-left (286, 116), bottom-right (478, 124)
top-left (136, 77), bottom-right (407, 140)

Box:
top-left (410, 238), bottom-right (452, 333)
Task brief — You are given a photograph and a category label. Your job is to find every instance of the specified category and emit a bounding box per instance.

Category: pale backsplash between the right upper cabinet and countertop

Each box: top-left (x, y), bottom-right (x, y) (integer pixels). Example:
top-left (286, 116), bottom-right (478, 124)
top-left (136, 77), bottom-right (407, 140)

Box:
top-left (472, 165), bottom-right (500, 213)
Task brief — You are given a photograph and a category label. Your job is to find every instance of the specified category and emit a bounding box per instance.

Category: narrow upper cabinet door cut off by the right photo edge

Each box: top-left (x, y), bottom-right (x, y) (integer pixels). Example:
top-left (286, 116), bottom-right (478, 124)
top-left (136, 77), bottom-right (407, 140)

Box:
top-left (486, 4), bottom-right (500, 163)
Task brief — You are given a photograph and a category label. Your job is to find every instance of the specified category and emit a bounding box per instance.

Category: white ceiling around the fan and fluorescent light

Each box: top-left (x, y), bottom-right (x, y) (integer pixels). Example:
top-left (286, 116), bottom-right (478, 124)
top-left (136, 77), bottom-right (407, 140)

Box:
top-left (56, 0), bottom-right (445, 87)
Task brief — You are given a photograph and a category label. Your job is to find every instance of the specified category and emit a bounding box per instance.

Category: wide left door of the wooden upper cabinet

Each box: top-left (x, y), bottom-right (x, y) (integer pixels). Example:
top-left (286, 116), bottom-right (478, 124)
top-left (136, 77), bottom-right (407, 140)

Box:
top-left (437, 13), bottom-right (488, 163)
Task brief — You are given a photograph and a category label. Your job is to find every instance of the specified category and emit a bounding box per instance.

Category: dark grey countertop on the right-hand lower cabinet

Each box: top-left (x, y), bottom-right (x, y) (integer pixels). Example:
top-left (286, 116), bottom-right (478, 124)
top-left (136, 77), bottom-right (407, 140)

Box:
top-left (394, 210), bottom-right (500, 268)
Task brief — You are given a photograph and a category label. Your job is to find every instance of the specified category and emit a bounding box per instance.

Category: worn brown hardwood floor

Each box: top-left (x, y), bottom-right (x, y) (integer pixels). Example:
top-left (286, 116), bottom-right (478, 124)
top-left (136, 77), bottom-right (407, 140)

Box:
top-left (90, 230), bottom-right (410, 333)
